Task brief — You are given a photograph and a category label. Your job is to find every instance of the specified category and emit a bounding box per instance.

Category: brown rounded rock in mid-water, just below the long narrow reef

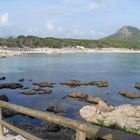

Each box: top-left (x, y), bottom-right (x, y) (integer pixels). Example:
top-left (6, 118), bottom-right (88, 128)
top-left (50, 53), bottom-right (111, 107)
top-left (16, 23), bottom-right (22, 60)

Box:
top-left (68, 92), bottom-right (88, 99)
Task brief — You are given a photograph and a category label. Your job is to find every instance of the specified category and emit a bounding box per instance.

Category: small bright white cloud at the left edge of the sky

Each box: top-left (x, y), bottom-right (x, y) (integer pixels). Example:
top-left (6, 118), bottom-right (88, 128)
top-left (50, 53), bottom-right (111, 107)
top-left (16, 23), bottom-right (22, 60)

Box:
top-left (0, 13), bottom-right (9, 26)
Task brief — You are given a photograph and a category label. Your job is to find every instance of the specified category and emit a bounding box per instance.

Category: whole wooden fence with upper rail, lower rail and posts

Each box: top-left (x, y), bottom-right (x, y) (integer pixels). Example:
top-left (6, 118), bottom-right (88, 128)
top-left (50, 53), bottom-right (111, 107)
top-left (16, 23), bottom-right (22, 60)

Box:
top-left (0, 101), bottom-right (140, 140)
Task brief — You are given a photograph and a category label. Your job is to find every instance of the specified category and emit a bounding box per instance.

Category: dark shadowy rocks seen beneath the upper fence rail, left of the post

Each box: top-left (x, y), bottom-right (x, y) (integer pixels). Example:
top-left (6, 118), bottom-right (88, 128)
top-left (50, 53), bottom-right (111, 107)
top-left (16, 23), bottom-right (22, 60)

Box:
top-left (14, 121), bottom-right (75, 140)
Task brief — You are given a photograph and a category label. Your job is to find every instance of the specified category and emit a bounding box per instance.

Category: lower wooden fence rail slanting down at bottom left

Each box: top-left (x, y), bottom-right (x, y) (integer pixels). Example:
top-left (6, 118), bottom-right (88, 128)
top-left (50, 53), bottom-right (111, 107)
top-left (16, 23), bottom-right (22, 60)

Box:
top-left (2, 120), bottom-right (42, 140)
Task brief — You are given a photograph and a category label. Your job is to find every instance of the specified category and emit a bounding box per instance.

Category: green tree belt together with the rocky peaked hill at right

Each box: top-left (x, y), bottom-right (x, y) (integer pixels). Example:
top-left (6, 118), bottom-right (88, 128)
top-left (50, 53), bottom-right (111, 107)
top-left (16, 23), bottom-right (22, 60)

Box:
top-left (0, 26), bottom-right (140, 49)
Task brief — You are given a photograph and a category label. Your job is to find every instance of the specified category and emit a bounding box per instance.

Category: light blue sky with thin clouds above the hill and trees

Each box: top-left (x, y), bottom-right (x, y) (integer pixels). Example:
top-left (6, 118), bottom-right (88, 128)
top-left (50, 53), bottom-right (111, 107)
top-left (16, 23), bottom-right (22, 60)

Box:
top-left (0, 0), bottom-right (140, 39)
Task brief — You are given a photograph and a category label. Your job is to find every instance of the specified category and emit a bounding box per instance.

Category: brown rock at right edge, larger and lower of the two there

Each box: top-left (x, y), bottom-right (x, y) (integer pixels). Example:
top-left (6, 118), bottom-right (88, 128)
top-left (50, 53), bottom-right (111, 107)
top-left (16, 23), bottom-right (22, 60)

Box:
top-left (119, 90), bottom-right (140, 99)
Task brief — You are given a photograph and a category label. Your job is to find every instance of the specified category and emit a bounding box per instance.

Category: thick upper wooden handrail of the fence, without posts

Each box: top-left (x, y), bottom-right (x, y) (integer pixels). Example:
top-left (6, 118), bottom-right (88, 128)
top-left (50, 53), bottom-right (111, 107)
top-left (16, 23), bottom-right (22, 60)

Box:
top-left (0, 101), bottom-right (140, 140)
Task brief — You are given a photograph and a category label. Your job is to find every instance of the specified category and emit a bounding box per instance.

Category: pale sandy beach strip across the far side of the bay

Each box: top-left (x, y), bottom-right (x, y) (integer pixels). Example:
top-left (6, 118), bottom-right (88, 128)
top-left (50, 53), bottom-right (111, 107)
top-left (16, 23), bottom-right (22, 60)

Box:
top-left (0, 46), bottom-right (140, 57)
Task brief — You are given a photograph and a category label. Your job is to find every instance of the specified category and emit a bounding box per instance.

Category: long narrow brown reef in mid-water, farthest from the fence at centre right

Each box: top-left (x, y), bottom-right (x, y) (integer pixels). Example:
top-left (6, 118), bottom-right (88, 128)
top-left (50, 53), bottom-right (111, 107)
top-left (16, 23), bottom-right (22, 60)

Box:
top-left (61, 80), bottom-right (108, 87)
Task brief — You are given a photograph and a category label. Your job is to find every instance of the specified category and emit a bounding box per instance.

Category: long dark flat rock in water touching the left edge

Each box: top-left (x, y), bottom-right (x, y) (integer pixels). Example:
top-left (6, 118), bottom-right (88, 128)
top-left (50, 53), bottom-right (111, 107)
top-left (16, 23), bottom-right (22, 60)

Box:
top-left (0, 83), bottom-right (23, 89)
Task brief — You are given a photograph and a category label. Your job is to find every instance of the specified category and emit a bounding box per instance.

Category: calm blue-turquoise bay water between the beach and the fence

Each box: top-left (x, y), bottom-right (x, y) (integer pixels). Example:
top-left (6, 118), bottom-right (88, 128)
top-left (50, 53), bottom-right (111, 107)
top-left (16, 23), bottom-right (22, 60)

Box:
top-left (0, 53), bottom-right (140, 118)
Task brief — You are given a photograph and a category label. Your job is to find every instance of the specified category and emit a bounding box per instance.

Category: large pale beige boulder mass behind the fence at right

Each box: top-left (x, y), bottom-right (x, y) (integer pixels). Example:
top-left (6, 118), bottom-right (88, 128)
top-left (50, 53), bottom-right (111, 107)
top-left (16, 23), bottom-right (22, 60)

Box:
top-left (80, 104), bottom-right (140, 132)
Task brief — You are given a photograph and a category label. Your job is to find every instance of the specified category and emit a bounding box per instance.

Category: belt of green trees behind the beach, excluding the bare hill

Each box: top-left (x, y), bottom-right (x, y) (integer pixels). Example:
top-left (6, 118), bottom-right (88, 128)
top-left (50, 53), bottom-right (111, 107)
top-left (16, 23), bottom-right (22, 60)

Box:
top-left (0, 36), bottom-right (140, 49)
